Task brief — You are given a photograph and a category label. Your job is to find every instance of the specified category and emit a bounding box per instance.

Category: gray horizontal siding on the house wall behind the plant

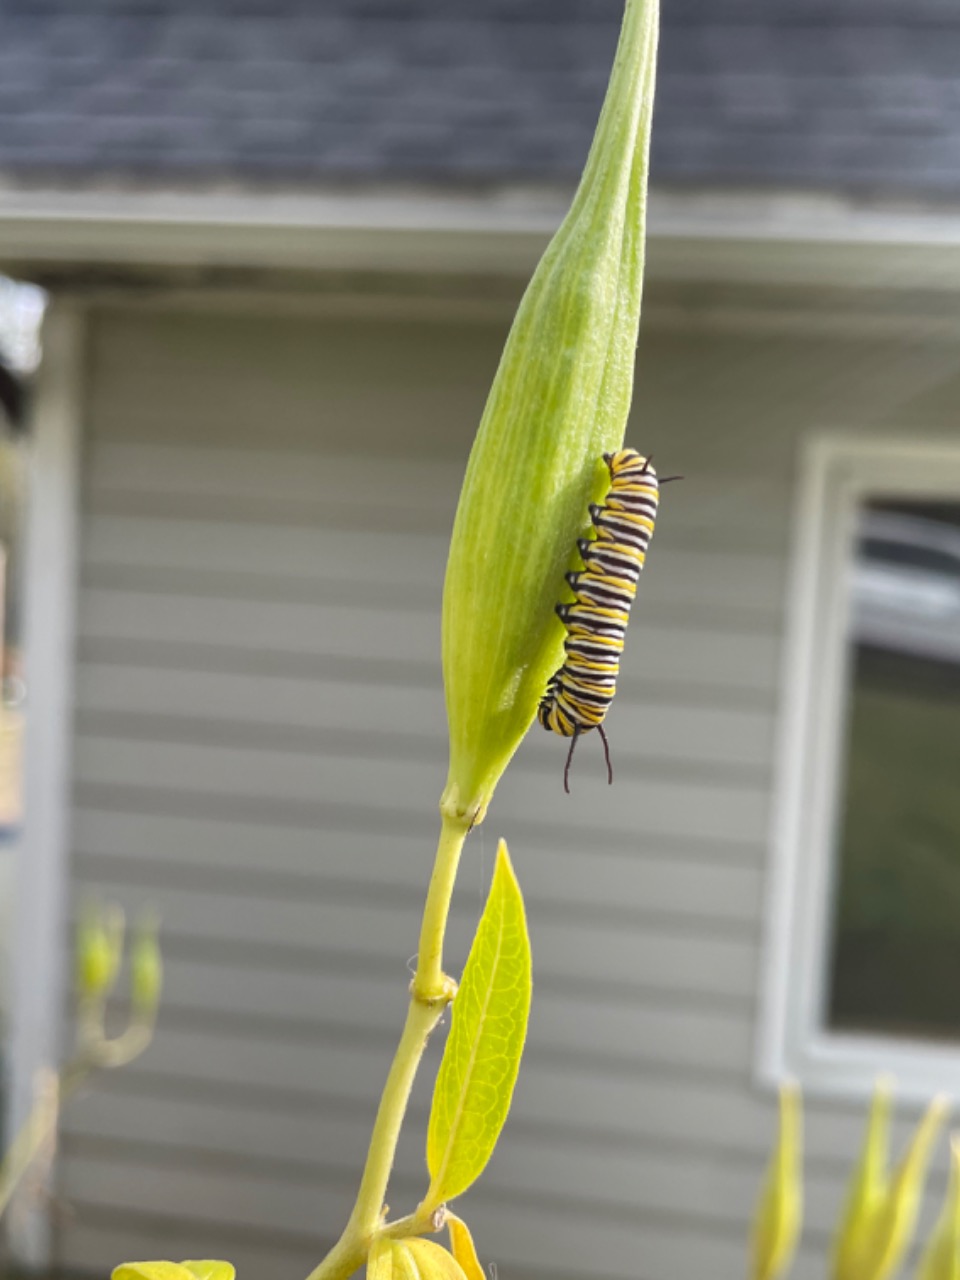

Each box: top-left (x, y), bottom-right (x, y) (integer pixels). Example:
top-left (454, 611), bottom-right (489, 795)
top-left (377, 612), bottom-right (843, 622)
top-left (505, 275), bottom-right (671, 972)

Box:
top-left (58, 302), bottom-right (957, 1280)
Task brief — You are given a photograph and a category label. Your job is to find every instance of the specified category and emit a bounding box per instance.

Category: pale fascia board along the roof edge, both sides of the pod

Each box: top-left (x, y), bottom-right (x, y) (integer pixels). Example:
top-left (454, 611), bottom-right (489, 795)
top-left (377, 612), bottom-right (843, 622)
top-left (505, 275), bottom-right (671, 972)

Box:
top-left (0, 188), bottom-right (960, 291)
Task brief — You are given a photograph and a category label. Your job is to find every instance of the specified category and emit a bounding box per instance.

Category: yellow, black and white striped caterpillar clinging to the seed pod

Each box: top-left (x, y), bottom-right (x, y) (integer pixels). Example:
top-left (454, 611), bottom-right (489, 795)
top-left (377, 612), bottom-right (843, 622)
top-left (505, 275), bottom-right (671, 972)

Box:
top-left (538, 449), bottom-right (675, 792)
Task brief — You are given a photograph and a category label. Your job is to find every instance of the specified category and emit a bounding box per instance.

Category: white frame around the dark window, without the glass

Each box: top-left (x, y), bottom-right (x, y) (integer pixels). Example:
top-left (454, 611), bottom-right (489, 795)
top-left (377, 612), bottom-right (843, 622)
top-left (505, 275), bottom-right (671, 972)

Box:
top-left (758, 435), bottom-right (960, 1098)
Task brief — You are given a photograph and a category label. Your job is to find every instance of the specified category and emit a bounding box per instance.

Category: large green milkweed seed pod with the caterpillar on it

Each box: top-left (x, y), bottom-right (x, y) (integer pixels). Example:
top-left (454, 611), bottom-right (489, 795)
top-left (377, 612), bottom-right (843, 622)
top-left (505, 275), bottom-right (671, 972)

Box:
top-left (442, 0), bottom-right (658, 822)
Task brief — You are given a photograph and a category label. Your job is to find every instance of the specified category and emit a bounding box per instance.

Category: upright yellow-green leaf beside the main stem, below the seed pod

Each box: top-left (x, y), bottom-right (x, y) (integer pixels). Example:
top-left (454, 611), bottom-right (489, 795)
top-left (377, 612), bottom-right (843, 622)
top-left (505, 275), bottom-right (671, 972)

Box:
top-left (424, 841), bottom-right (531, 1208)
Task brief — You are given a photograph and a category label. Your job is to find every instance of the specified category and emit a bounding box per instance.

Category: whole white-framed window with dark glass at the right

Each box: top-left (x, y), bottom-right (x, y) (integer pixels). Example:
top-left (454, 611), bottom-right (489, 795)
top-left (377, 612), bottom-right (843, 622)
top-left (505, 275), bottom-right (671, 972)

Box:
top-left (760, 439), bottom-right (960, 1097)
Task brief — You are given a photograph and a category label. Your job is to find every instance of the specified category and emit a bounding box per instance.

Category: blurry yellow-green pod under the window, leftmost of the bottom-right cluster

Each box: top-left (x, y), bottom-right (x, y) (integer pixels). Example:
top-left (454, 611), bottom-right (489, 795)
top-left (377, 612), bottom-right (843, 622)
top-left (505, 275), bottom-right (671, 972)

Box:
top-left (753, 1083), bottom-right (804, 1280)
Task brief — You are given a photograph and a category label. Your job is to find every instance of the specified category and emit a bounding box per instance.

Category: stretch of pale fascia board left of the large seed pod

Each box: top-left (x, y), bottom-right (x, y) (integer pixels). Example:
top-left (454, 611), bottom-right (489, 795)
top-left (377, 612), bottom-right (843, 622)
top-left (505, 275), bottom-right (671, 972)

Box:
top-left (0, 183), bottom-right (567, 275)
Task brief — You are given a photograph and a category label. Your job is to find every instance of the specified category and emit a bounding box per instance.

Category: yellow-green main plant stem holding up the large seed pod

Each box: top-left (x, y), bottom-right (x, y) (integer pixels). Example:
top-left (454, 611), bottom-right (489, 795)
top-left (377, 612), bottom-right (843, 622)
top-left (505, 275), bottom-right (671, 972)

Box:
top-left (307, 813), bottom-right (470, 1280)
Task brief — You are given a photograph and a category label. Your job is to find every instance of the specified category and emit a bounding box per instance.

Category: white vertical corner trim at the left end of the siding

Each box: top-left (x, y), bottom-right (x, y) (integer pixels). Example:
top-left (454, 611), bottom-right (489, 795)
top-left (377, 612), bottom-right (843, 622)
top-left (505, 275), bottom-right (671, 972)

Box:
top-left (6, 303), bottom-right (84, 1267)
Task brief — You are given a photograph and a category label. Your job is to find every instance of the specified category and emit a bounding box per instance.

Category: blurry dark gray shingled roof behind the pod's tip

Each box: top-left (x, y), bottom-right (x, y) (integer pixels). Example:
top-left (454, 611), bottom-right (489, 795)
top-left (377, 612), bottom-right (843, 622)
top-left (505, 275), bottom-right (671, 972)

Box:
top-left (0, 0), bottom-right (960, 195)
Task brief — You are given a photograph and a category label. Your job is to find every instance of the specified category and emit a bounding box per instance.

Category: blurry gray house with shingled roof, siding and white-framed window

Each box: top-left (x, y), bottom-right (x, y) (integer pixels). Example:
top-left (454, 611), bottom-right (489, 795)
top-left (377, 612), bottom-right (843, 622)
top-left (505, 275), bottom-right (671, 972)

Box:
top-left (0, 0), bottom-right (960, 1280)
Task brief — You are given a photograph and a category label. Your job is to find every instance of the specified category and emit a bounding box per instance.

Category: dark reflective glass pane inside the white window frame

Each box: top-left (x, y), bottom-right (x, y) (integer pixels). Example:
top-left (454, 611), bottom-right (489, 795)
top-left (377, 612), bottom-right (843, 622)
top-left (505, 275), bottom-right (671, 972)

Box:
top-left (827, 500), bottom-right (960, 1039)
